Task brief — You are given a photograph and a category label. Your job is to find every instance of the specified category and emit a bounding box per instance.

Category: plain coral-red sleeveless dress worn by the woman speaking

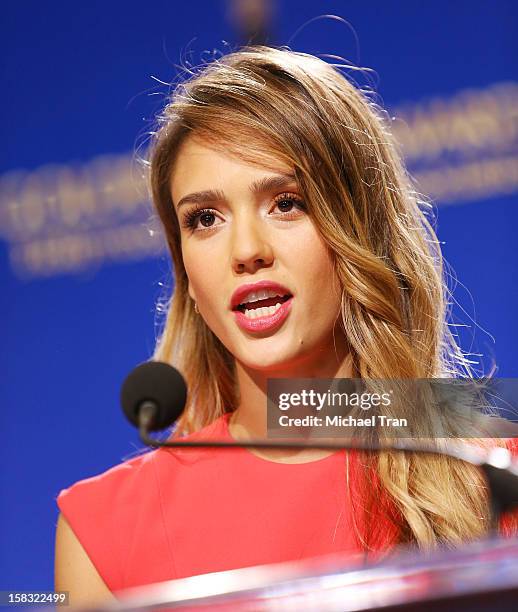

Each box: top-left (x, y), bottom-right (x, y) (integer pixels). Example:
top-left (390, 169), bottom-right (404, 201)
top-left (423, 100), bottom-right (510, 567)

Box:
top-left (57, 414), bottom-right (518, 592)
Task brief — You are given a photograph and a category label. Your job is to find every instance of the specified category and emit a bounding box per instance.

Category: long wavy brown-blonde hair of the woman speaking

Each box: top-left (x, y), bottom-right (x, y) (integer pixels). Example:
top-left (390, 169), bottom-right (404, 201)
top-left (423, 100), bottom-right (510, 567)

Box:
top-left (149, 46), bottom-right (516, 550)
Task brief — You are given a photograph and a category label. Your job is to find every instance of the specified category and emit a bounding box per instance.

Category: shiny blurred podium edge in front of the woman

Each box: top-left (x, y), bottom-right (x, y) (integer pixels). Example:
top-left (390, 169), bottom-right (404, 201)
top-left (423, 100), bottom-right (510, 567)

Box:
top-left (74, 538), bottom-right (518, 612)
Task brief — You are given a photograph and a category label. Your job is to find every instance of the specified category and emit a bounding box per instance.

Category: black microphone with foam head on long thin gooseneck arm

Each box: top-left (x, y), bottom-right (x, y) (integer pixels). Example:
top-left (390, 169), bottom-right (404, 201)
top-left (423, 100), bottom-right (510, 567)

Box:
top-left (121, 361), bottom-right (518, 529)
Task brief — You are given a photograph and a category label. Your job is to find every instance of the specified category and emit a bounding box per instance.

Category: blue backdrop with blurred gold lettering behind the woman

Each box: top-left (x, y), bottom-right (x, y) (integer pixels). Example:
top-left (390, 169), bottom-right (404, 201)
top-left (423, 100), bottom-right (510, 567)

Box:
top-left (0, 0), bottom-right (518, 590)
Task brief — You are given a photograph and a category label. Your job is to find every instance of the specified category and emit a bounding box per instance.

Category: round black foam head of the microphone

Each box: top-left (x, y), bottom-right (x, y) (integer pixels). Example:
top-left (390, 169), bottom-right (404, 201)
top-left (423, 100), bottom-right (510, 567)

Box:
top-left (121, 361), bottom-right (187, 431)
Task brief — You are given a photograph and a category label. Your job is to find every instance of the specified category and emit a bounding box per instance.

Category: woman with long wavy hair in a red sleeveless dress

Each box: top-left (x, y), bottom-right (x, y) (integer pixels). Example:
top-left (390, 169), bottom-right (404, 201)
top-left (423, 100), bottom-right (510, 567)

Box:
top-left (56, 47), bottom-right (514, 603)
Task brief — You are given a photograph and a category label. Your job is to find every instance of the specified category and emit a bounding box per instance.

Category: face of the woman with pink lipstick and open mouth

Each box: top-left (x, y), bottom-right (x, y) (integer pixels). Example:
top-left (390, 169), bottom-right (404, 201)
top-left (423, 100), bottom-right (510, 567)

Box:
top-left (171, 136), bottom-right (350, 370)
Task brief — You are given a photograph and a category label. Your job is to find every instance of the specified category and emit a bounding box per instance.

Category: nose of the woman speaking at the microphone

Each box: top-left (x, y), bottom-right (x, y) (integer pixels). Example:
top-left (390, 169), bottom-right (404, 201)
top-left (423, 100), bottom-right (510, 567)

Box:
top-left (231, 216), bottom-right (273, 272)
